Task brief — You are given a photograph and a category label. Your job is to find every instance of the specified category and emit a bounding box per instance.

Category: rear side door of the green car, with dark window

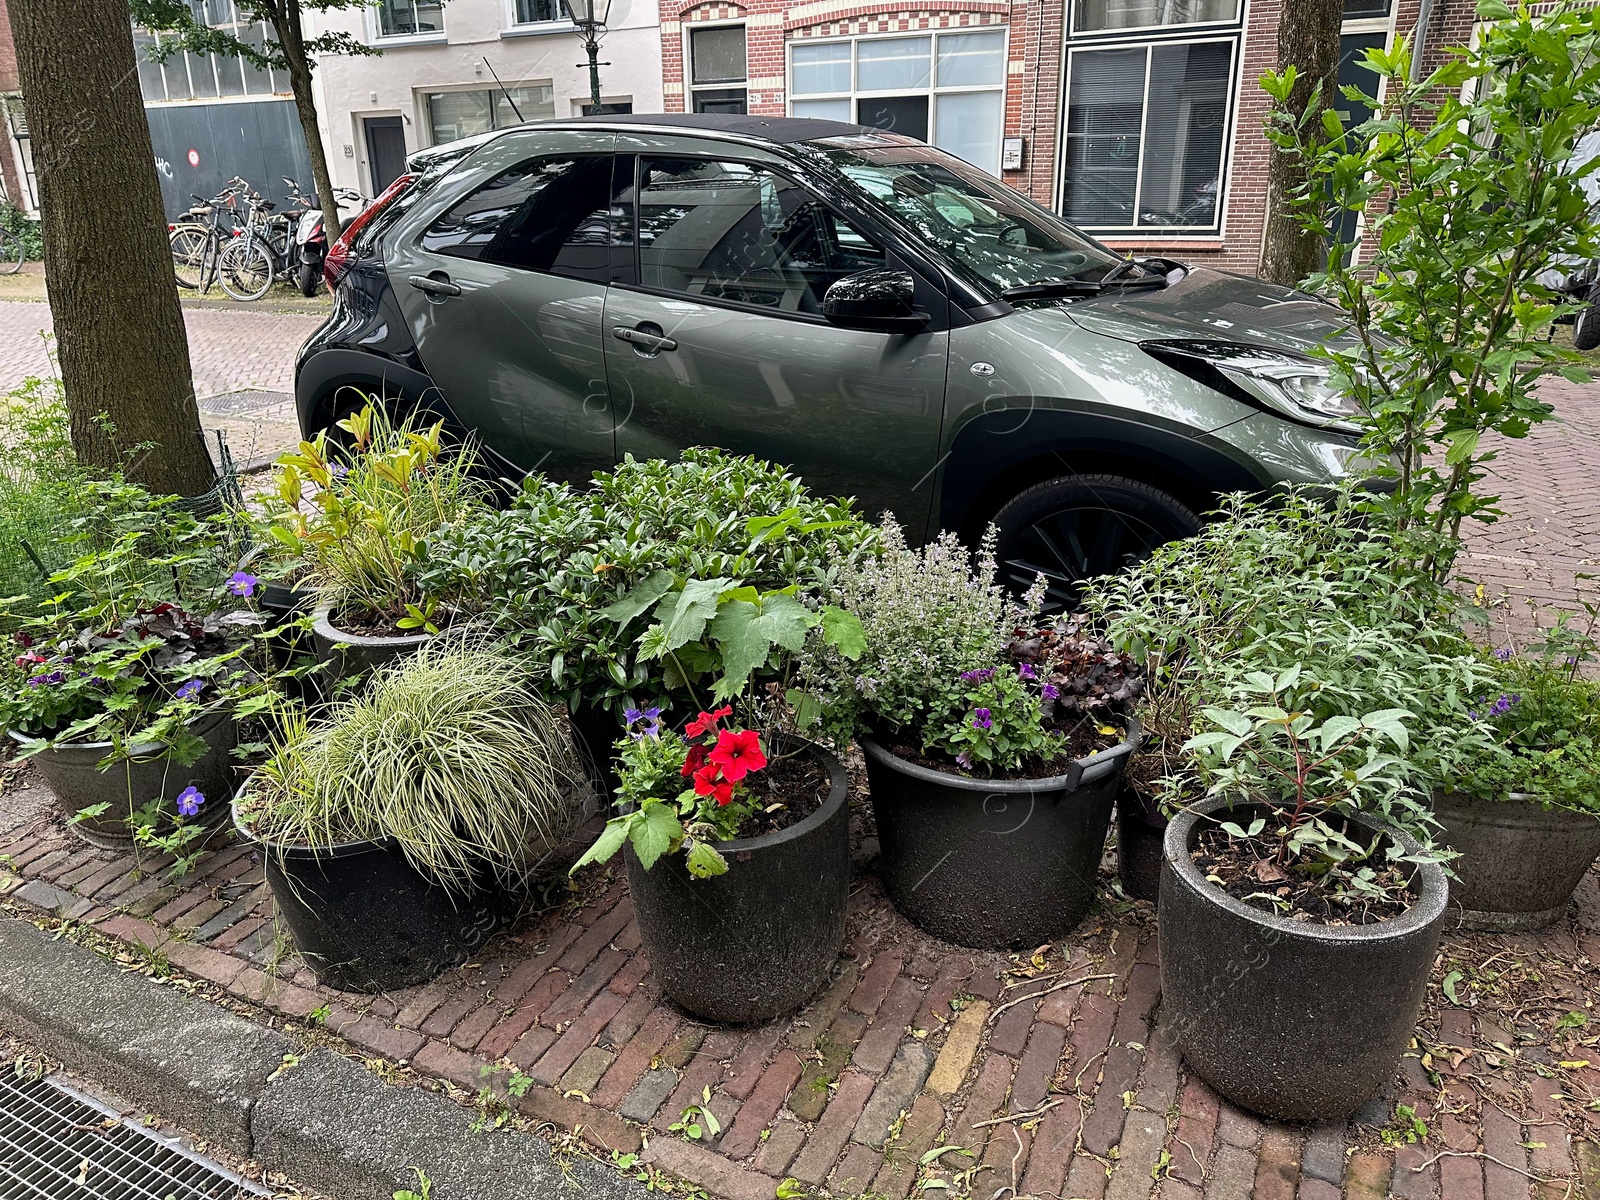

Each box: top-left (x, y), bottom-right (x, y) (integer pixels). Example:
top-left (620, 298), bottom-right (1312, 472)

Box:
top-left (387, 131), bottom-right (614, 480)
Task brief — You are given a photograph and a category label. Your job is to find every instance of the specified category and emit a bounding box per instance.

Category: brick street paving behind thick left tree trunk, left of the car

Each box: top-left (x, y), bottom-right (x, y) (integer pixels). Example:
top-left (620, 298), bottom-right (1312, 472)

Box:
top-left (0, 301), bottom-right (322, 464)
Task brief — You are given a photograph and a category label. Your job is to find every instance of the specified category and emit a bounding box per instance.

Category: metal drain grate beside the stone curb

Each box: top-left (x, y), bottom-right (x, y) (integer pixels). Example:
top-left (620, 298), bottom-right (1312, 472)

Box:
top-left (0, 1074), bottom-right (269, 1200)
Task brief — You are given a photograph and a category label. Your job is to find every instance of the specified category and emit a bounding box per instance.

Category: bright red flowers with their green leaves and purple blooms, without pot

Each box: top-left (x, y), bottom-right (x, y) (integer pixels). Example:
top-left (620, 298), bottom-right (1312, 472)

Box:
top-left (573, 704), bottom-right (766, 878)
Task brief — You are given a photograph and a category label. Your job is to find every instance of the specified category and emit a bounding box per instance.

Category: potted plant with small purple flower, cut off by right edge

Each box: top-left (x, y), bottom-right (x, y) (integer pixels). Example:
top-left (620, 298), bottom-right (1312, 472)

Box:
top-left (1434, 633), bottom-right (1600, 931)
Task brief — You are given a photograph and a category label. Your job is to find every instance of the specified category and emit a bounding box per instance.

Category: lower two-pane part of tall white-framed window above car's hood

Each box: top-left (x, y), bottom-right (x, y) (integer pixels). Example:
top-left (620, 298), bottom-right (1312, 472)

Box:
top-left (1061, 38), bottom-right (1235, 232)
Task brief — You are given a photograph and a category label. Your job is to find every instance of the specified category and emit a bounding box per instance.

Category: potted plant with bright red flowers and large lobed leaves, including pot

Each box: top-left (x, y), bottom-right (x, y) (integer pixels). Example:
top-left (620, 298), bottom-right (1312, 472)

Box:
top-left (573, 571), bottom-right (861, 1024)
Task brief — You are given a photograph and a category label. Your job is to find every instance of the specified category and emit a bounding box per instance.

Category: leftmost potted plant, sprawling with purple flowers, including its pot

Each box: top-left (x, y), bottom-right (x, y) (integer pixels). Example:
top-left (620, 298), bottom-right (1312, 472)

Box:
top-left (0, 482), bottom-right (266, 870)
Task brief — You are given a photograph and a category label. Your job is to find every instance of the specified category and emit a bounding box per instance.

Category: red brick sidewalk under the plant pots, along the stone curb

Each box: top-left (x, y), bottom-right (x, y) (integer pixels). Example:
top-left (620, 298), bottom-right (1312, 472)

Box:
top-left (0, 789), bottom-right (1600, 1200)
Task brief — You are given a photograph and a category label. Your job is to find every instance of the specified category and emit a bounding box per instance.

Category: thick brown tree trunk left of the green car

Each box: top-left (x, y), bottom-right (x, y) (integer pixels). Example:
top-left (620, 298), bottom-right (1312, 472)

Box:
top-left (10, 0), bottom-right (216, 496)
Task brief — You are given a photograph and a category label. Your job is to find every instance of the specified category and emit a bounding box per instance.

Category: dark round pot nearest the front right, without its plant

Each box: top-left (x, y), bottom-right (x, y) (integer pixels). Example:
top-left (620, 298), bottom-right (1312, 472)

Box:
top-left (1157, 798), bottom-right (1450, 1122)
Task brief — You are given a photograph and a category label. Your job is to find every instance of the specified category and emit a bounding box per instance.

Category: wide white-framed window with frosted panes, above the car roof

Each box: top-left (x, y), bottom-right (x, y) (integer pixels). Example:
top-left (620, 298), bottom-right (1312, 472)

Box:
top-left (789, 30), bottom-right (1005, 174)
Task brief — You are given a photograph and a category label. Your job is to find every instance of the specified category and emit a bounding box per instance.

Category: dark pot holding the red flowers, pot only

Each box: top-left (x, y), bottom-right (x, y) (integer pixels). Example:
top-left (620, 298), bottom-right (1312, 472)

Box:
top-left (624, 741), bottom-right (850, 1026)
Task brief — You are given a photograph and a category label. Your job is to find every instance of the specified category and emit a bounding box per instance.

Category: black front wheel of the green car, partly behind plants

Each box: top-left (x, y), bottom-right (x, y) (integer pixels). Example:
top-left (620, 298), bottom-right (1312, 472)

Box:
top-left (994, 475), bottom-right (1202, 613)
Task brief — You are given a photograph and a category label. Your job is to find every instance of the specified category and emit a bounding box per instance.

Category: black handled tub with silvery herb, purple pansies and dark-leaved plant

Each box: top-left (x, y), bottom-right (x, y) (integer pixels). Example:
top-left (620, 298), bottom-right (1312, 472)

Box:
top-left (814, 523), bottom-right (1142, 949)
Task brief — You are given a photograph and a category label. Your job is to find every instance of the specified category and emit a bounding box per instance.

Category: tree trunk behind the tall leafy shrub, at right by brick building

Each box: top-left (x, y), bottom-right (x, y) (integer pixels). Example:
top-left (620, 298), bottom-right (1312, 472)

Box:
top-left (1258, 0), bottom-right (1344, 286)
